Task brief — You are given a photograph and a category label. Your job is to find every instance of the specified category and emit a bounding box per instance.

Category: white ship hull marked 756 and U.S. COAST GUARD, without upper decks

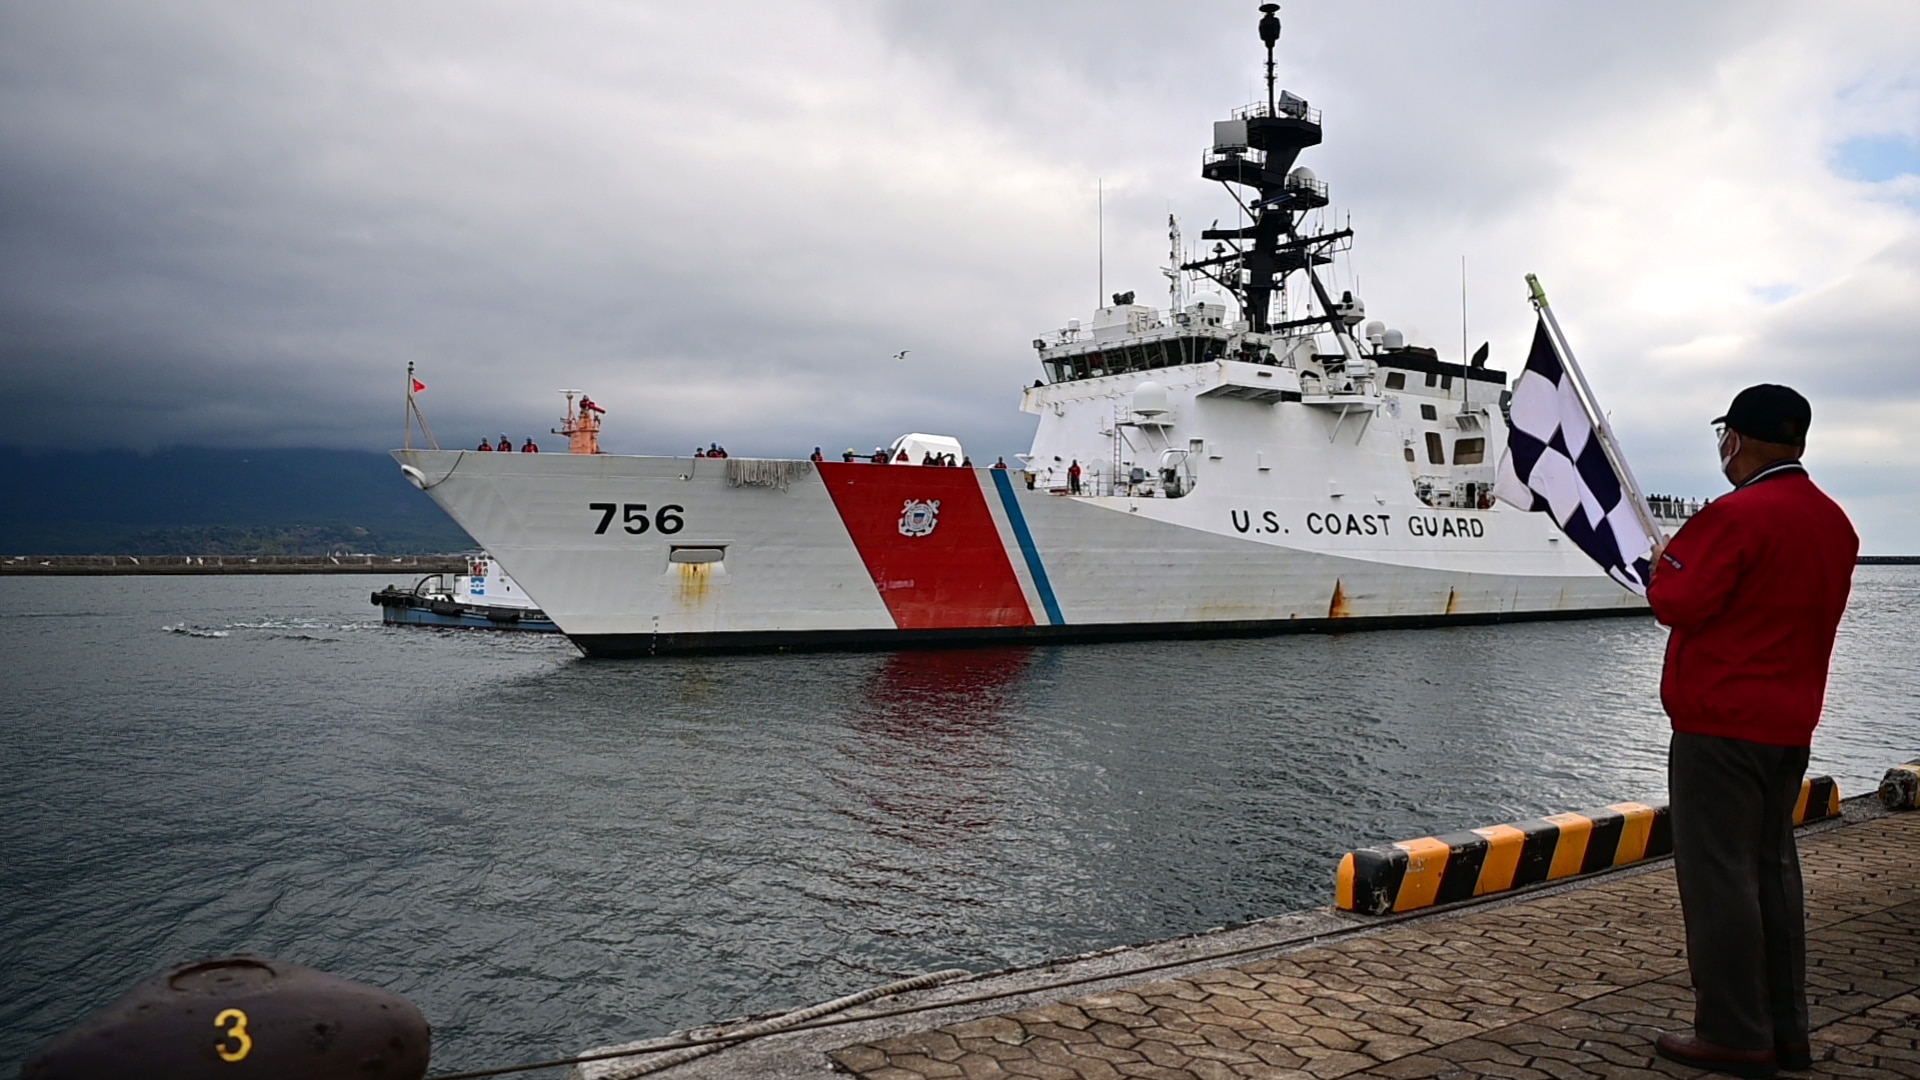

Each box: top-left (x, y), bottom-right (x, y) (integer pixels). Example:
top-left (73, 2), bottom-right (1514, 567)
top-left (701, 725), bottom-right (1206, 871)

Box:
top-left (394, 438), bottom-right (1645, 657)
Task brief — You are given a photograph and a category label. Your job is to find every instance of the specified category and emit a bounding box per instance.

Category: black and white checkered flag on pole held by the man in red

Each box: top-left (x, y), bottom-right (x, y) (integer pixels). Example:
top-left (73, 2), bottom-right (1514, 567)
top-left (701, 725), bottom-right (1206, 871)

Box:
top-left (1494, 275), bottom-right (1661, 596)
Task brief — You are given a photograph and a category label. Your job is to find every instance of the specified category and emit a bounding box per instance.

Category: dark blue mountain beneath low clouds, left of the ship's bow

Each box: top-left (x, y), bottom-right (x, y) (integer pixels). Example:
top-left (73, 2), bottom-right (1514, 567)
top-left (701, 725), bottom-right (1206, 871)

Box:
top-left (0, 446), bottom-right (474, 555)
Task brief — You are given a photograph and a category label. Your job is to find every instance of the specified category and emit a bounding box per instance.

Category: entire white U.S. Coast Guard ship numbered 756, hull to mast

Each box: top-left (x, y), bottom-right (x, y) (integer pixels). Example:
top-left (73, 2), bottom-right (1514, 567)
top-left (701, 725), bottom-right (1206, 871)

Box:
top-left (394, 4), bottom-right (1645, 657)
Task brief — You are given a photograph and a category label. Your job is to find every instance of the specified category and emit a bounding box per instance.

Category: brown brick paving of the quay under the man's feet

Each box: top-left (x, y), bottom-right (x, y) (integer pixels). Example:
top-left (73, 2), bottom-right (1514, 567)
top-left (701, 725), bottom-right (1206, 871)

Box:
top-left (829, 813), bottom-right (1920, 1080)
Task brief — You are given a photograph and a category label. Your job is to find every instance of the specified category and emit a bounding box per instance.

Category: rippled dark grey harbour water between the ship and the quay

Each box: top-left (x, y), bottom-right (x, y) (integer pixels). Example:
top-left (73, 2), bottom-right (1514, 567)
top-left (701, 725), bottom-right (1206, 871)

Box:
top-left (0, 567), bottom-right (1920, 1070)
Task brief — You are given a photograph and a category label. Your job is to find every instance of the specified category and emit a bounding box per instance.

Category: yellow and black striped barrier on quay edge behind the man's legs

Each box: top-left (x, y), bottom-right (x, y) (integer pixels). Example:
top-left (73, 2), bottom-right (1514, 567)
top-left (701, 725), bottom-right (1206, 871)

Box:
top-left (1334, 776), bottom-right (1839, 915)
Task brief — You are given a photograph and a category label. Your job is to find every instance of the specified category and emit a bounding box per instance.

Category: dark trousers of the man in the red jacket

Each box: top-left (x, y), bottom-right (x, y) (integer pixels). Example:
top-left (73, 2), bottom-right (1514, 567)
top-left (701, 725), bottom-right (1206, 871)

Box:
top-left (1667, 732), bottom-right (1807, 1049)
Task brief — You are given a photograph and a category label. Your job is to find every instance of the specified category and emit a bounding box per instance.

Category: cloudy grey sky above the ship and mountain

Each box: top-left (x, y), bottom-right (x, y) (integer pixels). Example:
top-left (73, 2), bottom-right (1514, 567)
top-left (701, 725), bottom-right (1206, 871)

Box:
top-left (0, 0), bottom-right (1920, 552)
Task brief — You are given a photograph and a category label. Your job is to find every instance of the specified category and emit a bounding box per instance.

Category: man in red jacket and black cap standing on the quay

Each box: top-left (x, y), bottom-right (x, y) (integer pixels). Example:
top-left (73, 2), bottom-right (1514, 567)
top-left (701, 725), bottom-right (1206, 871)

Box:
top-left (1647, 384), bottom-right (1860, 1076)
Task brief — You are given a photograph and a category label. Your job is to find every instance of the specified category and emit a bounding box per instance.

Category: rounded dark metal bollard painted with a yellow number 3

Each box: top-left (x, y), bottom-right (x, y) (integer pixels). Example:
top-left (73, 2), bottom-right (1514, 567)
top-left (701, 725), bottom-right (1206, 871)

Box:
top-left (19, 957), bottom-right (432, 1080)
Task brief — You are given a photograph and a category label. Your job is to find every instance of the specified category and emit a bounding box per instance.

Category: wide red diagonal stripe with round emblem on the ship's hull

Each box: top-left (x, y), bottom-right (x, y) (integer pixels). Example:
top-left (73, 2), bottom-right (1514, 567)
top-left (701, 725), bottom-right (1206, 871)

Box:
top-left (820, 461), bottom-right (1033, 630)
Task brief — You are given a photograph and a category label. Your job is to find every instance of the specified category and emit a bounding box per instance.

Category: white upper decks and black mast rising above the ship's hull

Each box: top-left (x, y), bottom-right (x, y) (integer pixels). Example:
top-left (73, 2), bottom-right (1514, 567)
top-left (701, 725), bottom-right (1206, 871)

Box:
top-left (1021, 4), bottom-right (1507, 509)
